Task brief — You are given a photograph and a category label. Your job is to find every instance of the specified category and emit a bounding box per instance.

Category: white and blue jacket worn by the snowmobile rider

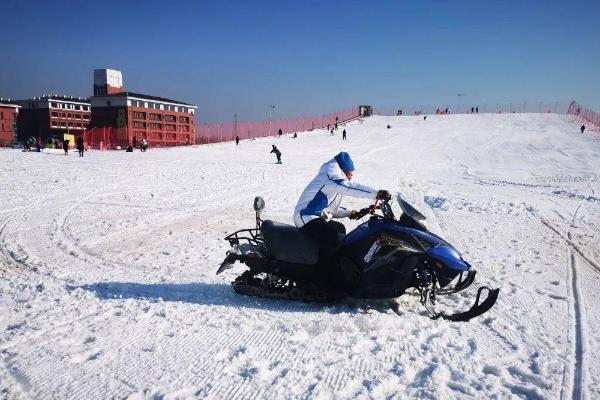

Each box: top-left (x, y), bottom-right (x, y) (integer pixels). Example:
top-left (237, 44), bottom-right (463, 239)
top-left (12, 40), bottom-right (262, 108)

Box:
top-left (294, 159), bottom-right (377, 228)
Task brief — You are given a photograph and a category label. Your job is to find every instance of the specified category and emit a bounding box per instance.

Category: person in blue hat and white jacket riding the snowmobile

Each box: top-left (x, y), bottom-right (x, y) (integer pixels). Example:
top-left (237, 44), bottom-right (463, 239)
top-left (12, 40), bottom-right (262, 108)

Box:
top-left (294, 152), bottom-right (391, 266)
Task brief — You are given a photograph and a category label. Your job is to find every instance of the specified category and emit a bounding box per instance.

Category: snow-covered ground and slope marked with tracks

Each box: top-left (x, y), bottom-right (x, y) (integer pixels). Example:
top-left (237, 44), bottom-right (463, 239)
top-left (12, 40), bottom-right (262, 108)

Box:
top-left (0, 114), bottom-right (600, 399)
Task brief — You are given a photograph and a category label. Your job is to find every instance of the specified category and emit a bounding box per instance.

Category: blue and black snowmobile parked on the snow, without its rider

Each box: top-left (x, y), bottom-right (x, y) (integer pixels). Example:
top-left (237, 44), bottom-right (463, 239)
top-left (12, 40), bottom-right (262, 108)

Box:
top-left (217, 194), bottom-right (500, 321)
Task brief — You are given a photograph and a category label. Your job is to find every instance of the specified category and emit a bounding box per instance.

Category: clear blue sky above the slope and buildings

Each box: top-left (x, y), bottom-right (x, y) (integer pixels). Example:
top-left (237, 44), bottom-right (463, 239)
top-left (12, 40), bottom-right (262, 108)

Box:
top-left (0, 0), bottom-right (600, 122)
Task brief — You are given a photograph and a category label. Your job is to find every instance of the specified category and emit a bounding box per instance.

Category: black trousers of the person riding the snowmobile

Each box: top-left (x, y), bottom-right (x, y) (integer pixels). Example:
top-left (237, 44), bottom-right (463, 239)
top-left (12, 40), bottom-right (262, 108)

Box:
top-left (300, 218), bottom-right (346, 280)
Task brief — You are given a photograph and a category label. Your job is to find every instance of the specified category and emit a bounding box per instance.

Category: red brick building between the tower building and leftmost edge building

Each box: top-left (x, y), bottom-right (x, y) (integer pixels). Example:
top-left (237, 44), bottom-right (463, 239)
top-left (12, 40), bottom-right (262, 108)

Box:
top-left (15, 95), bottom-right (91, 142)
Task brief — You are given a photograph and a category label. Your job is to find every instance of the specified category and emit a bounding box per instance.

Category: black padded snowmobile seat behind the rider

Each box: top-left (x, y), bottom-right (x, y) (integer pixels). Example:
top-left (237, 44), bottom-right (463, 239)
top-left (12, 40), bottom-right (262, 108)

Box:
top-left (261, 220), bottom-right (319, 265)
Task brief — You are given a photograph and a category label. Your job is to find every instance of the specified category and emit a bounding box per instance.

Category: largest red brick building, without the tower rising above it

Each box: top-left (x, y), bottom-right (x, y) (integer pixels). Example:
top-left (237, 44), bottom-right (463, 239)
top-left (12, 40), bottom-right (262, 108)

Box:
top-left (90, 92), bottom-right (197, 147)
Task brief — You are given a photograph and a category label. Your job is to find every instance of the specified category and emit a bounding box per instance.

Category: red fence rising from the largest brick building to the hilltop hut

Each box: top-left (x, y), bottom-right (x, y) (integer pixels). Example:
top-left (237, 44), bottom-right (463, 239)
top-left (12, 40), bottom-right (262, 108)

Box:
top-left (196, 107), bottom-right (359, 144)
